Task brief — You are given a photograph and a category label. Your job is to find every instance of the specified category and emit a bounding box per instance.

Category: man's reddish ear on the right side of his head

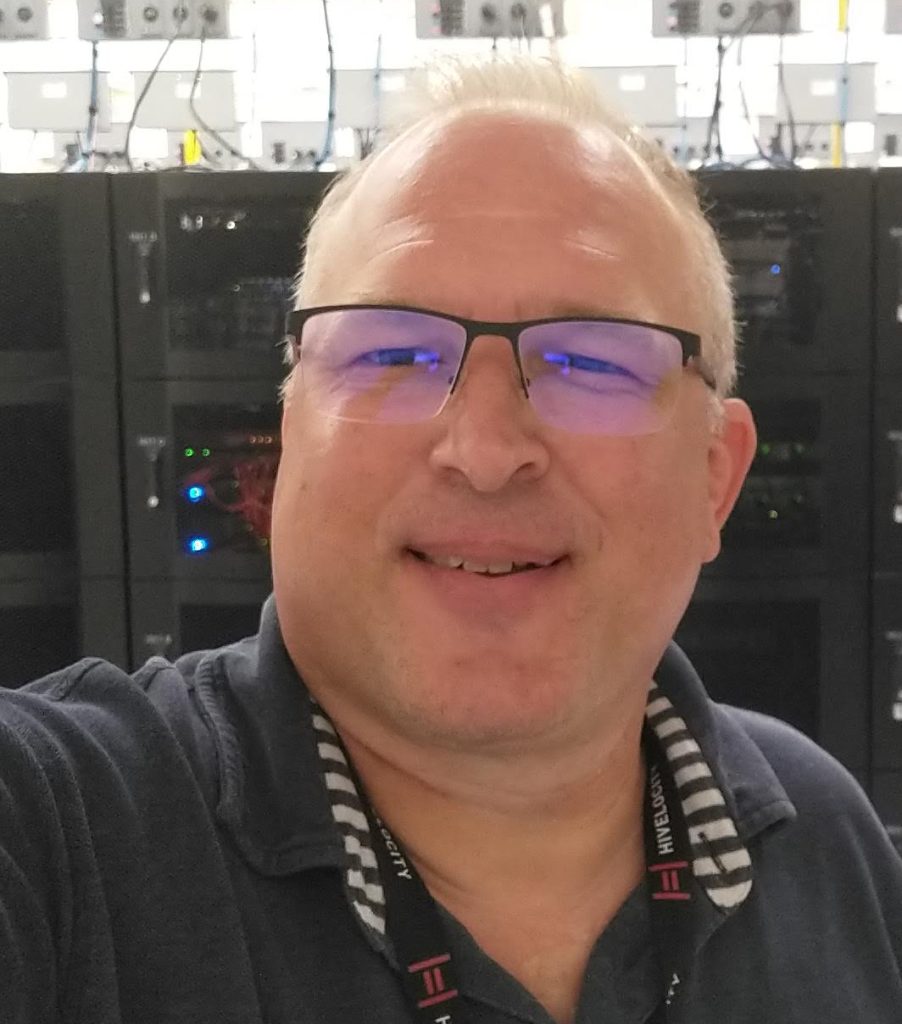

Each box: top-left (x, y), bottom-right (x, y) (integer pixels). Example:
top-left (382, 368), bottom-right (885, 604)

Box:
top-left (704, 398), bottom-right (758, 562)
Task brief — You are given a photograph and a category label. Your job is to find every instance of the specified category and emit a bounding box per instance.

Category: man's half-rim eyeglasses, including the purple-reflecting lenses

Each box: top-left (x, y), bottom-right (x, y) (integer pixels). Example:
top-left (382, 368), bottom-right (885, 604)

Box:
top-left (287, 305), bottom-right (715, 435)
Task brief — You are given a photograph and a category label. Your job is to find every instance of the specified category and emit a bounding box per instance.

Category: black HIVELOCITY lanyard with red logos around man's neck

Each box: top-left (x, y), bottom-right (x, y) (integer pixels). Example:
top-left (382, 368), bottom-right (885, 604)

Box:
top-left (358, 726), bottom-right (696, 1024)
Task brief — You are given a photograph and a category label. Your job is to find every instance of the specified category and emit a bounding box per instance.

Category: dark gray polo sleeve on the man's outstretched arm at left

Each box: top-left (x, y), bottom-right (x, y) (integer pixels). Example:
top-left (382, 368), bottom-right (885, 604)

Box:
top-left (0, 658), bottom-right (258, 1024)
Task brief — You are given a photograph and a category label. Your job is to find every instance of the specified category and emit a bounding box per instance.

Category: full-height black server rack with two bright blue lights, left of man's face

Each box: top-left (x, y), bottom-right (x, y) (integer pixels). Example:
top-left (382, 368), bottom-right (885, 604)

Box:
top-left (112, 172), bottom-right (333, 665)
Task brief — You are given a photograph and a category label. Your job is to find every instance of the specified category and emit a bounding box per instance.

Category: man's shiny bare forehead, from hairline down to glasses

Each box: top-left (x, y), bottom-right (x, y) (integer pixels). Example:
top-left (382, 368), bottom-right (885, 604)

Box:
top-left (308, 114), bottom-right (684, 319)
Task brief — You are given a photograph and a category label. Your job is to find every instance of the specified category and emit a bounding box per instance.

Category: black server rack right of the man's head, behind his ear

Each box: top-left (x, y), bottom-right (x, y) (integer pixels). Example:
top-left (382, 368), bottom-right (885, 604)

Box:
top-left (677, 170), bottom-right (873, 784)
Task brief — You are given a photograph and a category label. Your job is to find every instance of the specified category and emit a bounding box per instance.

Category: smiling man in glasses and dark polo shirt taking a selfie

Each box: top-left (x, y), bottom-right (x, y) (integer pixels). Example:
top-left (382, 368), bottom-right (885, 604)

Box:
top-left (0, 61), bottom-right (902, 1024)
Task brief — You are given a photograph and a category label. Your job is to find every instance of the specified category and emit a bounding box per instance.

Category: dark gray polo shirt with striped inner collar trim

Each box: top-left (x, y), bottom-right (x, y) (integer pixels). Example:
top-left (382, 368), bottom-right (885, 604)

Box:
top-left (0, 599), bottom-right (902, 1024)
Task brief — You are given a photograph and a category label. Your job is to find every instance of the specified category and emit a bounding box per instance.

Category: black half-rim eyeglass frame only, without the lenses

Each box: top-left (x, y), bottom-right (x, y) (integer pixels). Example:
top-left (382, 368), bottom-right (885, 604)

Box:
top-left (285, 302), bottom-right (717, 398)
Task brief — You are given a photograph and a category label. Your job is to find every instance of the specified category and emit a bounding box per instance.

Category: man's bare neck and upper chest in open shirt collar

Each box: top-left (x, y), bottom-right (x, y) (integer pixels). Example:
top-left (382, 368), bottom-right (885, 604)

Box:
top-left (336, 714), bottom-right (645, 1024)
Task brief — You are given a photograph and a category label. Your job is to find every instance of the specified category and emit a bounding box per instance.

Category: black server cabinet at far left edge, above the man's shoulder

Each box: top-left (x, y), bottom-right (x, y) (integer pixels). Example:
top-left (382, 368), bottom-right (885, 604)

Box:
top-left (0, 175), bottom-right (128, 686)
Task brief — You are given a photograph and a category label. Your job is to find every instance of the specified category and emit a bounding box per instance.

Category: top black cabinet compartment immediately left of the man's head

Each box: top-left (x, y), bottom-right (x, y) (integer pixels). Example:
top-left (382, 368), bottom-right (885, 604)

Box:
top-left (113, 172), bottom-right (333, 381)
